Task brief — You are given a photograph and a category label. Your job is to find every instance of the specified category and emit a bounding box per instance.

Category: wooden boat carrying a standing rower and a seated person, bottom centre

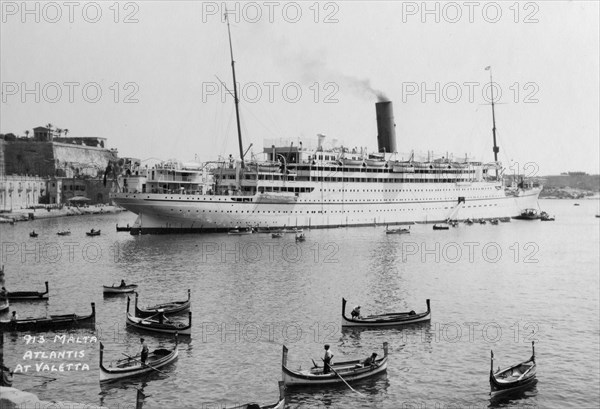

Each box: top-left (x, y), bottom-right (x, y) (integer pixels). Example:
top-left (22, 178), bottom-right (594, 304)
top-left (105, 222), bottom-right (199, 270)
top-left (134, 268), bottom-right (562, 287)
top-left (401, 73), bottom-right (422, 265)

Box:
top-left (281, 342), bottom-right (388, 386)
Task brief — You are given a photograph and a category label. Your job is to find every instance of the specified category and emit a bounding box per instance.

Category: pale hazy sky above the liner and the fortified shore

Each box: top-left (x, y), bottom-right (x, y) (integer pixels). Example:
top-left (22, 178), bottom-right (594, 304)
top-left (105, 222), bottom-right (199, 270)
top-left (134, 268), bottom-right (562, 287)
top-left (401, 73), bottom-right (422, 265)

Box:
top-left (0, 0), bottom-right (600, 176)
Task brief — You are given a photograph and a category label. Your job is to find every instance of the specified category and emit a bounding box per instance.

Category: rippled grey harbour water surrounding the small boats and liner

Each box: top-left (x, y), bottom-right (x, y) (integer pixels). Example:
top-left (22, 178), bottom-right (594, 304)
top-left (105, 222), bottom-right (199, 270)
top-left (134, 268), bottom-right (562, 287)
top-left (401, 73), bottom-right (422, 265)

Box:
top-left (0, 200), bottom-right (600, 409)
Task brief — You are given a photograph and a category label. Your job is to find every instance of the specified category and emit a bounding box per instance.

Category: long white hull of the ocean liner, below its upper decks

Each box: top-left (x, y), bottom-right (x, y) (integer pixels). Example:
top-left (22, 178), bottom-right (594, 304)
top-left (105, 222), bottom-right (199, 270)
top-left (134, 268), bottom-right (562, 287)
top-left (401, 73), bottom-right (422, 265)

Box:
top-left (111, 182), bottom-right (541, 234)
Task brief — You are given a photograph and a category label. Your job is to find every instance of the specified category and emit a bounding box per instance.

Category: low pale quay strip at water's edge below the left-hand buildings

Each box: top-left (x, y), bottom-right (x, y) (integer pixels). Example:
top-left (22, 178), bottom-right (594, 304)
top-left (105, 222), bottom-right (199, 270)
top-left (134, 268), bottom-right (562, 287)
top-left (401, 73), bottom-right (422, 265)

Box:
top-left (0, 205), bottom-right (127, 224)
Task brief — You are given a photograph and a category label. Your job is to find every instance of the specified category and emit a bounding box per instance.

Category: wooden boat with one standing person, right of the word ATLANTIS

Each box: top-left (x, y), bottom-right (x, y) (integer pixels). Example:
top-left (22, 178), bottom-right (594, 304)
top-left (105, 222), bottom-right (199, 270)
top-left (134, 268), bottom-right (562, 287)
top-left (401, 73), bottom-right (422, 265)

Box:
top-left (100, 336), bottom-right (178, 383)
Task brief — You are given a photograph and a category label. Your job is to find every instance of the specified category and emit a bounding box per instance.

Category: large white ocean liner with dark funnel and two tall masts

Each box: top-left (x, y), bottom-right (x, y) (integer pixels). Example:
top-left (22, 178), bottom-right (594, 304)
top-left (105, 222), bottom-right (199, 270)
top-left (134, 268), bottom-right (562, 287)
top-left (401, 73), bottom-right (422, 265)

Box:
top-left (106, 20), bottom-right (541, 234)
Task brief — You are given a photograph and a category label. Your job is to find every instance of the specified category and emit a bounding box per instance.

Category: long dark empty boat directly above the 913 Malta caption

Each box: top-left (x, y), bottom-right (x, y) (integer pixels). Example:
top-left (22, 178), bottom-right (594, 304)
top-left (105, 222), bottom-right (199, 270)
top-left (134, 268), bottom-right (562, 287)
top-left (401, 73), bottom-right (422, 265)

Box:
top-left (0, 303), bottom-right (96, 332)
